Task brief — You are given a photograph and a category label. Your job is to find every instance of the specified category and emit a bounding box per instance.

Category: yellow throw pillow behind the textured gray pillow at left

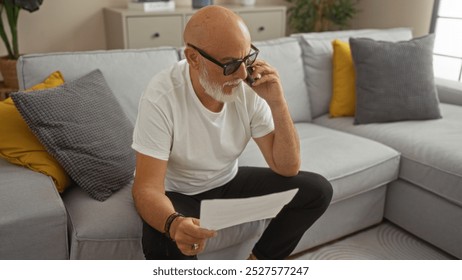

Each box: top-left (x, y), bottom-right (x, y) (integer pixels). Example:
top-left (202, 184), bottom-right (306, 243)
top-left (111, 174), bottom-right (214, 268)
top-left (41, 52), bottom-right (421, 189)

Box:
top-left (0, 71), bottom-right (70, 193)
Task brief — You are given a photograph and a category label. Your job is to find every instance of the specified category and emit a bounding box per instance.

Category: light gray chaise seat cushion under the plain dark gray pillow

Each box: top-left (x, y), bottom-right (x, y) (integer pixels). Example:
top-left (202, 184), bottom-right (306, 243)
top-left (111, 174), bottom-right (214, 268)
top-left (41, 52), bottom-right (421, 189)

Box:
top-left (314, 103), bottom-right (462, 206)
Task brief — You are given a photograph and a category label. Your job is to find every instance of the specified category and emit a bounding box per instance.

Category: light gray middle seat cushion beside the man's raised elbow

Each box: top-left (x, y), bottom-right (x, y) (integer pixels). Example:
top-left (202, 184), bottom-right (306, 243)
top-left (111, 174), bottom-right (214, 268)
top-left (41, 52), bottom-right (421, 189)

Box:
top-left (239, 123), bottom-right (400, 203)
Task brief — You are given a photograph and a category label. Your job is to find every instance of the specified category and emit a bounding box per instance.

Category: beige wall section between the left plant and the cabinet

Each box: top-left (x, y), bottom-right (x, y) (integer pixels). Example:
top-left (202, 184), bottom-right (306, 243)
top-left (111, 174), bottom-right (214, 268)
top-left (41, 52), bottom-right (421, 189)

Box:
top-left (10, 0), bottom-right (126, 53)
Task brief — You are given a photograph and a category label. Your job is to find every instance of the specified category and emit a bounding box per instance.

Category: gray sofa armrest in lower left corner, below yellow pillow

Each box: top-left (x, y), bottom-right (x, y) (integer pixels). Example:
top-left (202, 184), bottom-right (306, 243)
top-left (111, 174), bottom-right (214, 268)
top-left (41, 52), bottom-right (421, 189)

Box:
top-left (0, 158), bottom-right (69, 259)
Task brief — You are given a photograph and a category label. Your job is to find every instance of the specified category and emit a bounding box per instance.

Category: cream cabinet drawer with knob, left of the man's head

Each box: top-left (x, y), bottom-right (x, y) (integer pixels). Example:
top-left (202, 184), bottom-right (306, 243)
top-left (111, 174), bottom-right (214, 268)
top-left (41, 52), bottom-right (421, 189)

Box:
top-left (127, 16), bottom-right (183, 48)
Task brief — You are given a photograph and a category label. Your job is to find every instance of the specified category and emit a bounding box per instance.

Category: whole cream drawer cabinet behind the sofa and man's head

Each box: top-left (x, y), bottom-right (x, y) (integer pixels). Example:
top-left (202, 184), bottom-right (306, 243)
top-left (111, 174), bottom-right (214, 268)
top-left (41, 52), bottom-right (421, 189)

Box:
top-left (104, 6), bottom-right (286, 49)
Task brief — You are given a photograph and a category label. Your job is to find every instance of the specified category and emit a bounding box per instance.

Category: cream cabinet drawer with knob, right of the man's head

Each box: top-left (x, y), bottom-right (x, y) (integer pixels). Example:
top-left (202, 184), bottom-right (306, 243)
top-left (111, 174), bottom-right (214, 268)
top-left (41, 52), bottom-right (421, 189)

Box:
top-left (239, 11), bottom-right (285, 41)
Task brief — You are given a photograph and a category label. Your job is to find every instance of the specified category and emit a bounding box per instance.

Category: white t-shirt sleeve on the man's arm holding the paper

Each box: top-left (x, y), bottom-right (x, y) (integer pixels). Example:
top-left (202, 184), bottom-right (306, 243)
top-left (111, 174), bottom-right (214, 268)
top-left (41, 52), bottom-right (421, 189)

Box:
top-left (132, 94), bottom-right (173, 160)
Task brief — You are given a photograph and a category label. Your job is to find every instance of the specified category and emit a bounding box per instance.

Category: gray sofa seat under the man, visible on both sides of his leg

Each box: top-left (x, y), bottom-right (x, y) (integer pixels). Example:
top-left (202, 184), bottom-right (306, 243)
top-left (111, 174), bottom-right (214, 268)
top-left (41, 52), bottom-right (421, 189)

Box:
top-left (63, 180), bottom-right (266, 260)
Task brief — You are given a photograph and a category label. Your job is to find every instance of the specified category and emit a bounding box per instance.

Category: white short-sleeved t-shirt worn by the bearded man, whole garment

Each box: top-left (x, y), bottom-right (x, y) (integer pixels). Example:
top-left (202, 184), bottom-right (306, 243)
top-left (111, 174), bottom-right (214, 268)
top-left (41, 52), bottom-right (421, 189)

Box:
top-left (132, 60), bottom-right (274, 195)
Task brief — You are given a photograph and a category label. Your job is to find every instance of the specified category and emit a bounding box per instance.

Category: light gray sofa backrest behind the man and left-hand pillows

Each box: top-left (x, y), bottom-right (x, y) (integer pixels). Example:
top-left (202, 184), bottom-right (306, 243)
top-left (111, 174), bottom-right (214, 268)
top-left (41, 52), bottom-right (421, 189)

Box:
top-left (17, 48), bottom-right (178, 123)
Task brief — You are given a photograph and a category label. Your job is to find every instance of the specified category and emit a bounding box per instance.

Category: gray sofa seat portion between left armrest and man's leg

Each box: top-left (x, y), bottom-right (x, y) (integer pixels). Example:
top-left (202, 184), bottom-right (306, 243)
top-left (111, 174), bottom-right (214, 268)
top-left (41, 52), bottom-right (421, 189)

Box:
top-left (63, 183), bottom-right (144, 260)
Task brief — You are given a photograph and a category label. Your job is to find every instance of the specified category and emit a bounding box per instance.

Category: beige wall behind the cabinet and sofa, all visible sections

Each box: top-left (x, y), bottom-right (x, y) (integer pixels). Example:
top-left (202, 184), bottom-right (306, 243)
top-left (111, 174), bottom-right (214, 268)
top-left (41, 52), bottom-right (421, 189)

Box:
top-left (0, 0), bottom-right (433, 54)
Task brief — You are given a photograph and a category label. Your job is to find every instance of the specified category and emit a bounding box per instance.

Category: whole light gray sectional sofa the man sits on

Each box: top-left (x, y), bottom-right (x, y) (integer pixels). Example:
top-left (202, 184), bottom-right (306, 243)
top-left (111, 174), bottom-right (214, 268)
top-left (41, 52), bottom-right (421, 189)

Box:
top-left (0, 28), bottom-right (462, 259)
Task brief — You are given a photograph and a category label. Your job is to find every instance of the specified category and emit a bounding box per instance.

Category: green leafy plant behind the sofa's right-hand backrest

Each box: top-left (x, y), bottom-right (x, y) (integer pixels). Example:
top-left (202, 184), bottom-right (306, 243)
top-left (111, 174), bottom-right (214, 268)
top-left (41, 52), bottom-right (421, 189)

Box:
top-left (286, 0), bottom-right (359, 32)
